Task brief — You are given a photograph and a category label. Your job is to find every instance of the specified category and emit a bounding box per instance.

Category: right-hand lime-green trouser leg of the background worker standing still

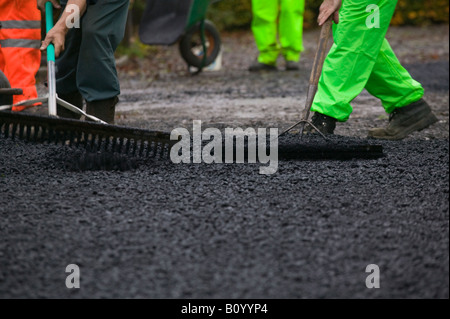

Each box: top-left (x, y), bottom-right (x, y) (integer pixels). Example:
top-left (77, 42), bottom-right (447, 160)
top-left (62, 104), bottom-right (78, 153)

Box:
top-left (279, 0), bottom-right (305, 62)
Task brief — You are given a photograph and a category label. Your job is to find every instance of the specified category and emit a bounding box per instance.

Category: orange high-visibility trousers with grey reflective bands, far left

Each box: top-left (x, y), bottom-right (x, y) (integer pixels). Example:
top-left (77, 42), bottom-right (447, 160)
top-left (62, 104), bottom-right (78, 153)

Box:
top-left (0, 0), bottom-right (41, 111)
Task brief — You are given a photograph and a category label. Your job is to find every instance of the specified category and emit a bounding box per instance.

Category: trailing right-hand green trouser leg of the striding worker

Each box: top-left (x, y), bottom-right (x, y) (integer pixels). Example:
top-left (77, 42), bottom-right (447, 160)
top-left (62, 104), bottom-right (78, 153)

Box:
top-left (366, 40), bottom-right (424, 113)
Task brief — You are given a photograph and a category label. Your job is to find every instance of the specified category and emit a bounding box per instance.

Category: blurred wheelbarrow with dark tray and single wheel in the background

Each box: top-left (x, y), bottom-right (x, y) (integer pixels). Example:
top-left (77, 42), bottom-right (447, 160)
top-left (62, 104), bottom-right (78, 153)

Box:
top-left (139, 0), bottom-right (222, 73)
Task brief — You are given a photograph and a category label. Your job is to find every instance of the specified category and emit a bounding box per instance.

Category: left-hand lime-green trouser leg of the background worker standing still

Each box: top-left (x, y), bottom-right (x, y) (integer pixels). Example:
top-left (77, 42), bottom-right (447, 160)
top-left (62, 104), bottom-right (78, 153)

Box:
top-left (252, 0), bottom-right (280, 65)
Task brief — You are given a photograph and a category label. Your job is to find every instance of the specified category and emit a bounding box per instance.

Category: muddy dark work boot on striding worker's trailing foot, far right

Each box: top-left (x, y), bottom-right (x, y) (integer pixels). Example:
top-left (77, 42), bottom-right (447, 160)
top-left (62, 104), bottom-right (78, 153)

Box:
top-left (368, 99), bottom-right (437, 140)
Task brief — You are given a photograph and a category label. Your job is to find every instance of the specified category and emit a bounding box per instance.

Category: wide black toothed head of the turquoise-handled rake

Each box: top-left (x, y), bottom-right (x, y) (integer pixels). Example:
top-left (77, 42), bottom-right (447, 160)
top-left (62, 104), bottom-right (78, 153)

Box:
top-left (0, 111), bottom-right (173, 158)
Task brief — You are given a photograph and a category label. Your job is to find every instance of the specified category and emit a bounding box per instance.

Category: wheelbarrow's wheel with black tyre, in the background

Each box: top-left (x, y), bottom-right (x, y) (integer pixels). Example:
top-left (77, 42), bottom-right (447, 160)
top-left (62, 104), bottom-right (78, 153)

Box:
top-left (179, 20), bottom-right (222, 69)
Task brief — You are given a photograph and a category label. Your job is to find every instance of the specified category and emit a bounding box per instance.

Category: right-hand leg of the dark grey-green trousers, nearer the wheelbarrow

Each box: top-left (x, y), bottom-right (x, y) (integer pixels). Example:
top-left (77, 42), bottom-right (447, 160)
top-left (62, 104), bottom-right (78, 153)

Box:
top-left (77, 0), bottom-right (129, 102)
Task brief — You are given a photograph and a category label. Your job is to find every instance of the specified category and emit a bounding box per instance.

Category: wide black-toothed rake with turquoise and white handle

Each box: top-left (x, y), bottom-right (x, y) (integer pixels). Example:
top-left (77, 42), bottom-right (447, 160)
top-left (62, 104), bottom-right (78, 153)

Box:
top-left (0, 2), bottom-right (175, 156)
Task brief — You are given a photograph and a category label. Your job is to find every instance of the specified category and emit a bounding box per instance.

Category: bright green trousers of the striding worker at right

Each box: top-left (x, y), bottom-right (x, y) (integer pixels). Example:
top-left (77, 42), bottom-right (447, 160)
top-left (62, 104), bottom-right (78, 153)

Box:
top-left (311, 0), bottom-right (424, 122)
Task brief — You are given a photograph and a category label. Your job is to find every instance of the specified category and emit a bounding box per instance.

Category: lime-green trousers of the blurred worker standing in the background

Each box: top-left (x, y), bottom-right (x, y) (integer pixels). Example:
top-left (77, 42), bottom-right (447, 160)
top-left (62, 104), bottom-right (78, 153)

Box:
top-left (252, 0), bottom-right (305, 65)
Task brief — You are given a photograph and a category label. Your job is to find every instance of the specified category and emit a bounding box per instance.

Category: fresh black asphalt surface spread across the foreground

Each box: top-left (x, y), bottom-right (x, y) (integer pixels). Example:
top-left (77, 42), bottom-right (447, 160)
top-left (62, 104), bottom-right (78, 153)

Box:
top-left (0, 63), bottom-right (449, 299)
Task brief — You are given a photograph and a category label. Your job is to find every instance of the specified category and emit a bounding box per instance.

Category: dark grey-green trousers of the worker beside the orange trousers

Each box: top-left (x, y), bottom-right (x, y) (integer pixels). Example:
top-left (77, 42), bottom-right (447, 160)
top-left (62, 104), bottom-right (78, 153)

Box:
top-left (56, 0), bottom-right (129, 102)
